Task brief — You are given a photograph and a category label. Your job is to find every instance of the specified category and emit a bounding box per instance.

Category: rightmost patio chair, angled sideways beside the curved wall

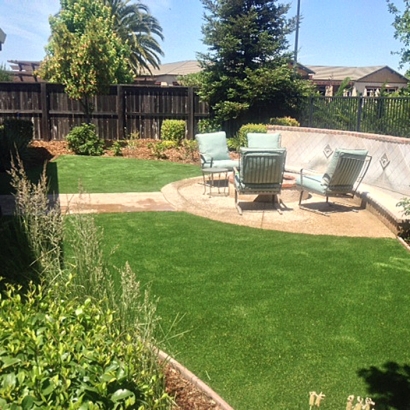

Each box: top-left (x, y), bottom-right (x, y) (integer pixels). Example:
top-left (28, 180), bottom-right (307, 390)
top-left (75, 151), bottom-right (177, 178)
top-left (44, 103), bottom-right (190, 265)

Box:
top-left (296, 149), bottom-right (372, 215)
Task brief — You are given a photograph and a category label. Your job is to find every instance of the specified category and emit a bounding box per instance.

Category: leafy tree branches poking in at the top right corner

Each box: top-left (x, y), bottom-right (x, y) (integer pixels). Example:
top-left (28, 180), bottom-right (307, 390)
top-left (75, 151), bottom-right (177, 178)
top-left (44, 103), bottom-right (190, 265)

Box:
top-left (386, 0), bottom-right (410, 76)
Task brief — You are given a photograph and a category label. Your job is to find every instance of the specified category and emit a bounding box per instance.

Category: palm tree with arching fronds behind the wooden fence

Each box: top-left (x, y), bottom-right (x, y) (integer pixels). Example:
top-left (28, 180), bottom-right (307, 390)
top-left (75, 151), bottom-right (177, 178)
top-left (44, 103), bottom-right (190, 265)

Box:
top-left (103, 0), bottom-right (164, 74)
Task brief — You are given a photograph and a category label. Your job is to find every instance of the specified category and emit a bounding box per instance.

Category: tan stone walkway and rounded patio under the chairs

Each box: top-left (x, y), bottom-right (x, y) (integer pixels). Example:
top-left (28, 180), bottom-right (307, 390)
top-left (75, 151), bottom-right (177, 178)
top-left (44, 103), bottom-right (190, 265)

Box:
top-left (0, 177), bottom-right (400, 238)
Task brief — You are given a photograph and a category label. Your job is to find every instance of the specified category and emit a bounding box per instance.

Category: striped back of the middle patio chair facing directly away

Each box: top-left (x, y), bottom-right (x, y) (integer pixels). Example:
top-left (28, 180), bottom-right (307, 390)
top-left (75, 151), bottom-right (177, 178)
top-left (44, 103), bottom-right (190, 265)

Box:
top-left (240, 148), bottom-right (286, 187)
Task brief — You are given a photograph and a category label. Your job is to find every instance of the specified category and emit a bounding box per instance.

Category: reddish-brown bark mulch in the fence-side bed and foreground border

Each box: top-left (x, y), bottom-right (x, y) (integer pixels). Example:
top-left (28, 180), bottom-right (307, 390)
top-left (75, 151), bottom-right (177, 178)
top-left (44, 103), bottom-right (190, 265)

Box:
top-left (30, 140), bottom-right (226, 410)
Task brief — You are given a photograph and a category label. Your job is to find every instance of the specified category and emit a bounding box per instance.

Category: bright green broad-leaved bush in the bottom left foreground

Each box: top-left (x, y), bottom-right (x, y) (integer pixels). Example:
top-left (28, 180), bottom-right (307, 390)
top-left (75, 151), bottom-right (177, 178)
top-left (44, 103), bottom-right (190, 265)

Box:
top-left (0, 282), bottom-right (169, 409)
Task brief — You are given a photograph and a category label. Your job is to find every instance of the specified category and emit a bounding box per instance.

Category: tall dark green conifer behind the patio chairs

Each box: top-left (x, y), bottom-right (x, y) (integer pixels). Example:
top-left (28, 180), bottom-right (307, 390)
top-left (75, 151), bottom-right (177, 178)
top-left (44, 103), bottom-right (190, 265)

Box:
top-left (195, 0), bottom-right (312, 125)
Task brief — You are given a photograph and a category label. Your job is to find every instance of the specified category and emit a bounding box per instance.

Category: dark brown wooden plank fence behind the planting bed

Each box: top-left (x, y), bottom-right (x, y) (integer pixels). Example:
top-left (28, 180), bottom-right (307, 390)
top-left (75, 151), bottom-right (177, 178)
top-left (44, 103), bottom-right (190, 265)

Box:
top-left (0, 82), bottom-right (209, 141)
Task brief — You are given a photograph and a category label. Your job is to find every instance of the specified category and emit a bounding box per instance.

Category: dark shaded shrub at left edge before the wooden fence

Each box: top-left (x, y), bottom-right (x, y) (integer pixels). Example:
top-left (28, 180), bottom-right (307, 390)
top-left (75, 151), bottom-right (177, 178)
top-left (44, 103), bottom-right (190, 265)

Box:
top-left (0, 119), bottom-right (33, 170)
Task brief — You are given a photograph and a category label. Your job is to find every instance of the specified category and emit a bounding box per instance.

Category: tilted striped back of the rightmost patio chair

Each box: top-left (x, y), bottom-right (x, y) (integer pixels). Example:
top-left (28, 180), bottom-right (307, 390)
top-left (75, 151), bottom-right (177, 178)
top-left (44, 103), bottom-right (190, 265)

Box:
top-left (322, 149), bottom-right (371, 192)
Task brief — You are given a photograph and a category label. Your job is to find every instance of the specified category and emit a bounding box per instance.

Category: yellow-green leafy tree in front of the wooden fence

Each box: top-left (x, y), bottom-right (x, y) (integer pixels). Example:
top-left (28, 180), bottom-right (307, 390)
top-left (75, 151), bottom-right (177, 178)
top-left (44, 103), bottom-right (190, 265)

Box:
top-left (39, 0), bottom-right (133, 122)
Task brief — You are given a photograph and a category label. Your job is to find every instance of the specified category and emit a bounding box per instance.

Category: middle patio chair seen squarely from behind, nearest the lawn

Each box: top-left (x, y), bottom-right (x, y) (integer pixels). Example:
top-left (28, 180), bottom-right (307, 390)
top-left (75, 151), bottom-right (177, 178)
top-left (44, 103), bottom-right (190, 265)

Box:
top-left (234, 148), bottom-right (286, 215)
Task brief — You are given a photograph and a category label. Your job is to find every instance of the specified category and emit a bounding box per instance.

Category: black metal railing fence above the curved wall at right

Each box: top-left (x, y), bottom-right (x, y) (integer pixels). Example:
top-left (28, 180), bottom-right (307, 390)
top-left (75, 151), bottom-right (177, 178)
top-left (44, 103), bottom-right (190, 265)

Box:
top-left (299, 97), bottom-right (410, 138)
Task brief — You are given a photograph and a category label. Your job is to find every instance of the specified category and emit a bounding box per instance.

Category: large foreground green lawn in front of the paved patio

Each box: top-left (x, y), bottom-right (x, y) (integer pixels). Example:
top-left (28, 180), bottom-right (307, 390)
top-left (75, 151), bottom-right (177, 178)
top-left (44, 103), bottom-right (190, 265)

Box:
top-left (96, 213), bottom-right (410, 410)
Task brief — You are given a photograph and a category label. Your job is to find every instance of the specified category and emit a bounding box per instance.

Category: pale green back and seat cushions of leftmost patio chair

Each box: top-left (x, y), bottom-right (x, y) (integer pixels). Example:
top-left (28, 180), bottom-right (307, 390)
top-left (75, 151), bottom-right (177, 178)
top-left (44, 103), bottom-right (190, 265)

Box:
top-left (195, 131), bottom-right (239, 171)
